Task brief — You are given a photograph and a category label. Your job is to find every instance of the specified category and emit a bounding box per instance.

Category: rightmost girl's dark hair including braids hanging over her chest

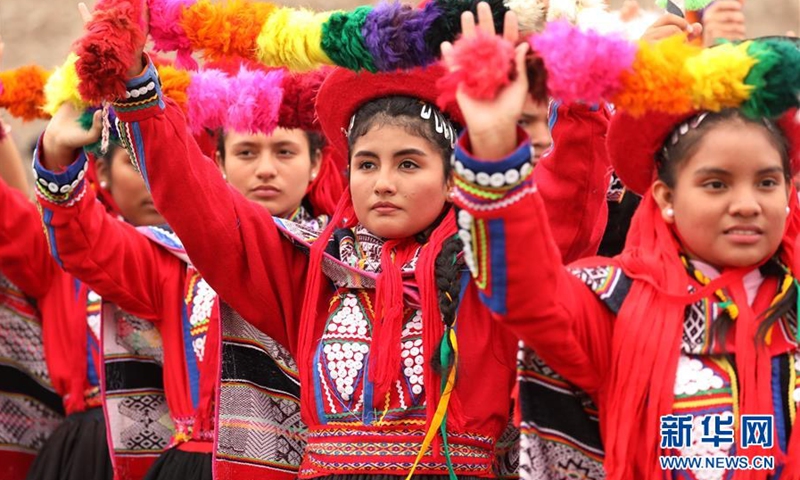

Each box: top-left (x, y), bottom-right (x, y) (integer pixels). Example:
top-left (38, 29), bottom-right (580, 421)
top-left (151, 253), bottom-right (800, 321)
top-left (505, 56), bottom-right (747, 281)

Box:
top-left (656, 109), bottom-right (797, 345)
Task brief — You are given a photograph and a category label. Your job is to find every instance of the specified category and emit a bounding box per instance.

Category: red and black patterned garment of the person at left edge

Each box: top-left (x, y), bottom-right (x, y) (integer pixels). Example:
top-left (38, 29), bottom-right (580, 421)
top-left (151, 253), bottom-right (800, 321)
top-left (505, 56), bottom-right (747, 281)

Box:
top-left (0, 178), bottom-right (111, 479)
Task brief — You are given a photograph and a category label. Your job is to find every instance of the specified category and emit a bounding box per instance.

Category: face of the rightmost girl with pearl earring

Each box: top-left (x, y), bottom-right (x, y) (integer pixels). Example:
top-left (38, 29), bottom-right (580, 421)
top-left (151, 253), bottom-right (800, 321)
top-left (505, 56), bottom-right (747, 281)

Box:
top-left (653, 122), bottom-right (790, 269)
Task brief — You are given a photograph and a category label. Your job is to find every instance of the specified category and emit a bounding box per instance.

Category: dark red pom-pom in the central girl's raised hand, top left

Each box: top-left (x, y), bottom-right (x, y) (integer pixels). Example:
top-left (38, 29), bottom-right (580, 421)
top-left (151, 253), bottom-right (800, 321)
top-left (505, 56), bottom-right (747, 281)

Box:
top-left (75, 0), bottom-right (144, 103)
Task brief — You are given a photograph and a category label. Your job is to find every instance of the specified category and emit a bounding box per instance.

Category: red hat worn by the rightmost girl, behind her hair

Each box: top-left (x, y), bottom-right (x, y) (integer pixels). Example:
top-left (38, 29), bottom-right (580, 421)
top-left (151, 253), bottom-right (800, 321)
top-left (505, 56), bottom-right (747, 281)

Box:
top-left (606, 109), bottom-right (800, 195)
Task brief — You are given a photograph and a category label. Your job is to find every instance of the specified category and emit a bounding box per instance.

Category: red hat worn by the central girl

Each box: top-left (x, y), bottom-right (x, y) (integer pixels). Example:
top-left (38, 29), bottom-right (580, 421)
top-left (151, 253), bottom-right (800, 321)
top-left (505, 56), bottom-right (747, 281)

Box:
top-left (316, 64), bottom-right (463, 158)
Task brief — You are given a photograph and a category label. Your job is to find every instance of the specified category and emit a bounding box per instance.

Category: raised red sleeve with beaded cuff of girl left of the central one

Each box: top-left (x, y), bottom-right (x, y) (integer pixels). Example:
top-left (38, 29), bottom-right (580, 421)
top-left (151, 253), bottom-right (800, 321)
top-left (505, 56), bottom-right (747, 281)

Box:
top-left (34, 150), bottom-right (177, 321)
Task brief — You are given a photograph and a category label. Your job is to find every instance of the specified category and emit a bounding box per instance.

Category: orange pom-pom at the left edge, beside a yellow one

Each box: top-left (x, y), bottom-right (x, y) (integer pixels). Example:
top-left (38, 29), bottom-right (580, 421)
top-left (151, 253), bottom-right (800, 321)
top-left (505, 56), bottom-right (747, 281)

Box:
top-left (0, 65), bottom-right (50, 121)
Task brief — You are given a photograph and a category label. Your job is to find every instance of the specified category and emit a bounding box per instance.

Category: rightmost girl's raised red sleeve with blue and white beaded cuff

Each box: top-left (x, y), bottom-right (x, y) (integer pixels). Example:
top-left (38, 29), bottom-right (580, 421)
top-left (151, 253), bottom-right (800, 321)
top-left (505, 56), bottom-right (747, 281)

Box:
top-left (454, 131), bottom-right (613, 395)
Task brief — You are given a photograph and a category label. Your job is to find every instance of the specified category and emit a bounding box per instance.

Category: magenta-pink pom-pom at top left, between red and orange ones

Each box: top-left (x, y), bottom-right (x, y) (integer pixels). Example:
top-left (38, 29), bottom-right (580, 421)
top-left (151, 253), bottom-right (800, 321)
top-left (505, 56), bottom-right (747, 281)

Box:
top-left (148, 0), bottom-right (197, 70)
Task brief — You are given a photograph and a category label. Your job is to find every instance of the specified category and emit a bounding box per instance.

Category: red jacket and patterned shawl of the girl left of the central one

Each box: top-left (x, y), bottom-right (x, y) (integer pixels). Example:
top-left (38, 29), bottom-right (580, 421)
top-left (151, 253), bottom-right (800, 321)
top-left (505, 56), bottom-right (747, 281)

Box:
top-left (37, 140), bottom-right (327, 479)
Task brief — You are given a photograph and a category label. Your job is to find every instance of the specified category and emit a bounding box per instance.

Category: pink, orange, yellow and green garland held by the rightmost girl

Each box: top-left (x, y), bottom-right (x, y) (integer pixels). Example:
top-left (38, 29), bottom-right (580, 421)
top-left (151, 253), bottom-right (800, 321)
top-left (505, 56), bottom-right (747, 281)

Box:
top-left (440, 21), bottom-right (800, 118)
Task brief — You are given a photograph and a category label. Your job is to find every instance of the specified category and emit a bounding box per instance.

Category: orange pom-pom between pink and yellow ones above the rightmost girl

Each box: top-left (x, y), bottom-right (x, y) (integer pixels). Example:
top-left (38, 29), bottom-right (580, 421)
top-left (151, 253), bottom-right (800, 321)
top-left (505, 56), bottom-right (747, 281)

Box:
top-left (611, 35), bottom-right (701, 115)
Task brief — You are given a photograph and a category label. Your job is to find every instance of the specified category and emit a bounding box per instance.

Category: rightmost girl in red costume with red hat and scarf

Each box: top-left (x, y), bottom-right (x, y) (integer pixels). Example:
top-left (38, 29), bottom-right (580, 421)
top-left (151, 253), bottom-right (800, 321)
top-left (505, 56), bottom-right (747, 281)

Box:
top-left (490, 36), bottom-right (800, 479)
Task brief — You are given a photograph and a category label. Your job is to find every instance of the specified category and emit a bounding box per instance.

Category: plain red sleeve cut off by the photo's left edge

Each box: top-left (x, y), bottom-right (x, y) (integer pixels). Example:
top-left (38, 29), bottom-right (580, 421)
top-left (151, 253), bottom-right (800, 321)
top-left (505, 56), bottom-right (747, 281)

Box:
top-left (0, 179), bottom-right (58, 298)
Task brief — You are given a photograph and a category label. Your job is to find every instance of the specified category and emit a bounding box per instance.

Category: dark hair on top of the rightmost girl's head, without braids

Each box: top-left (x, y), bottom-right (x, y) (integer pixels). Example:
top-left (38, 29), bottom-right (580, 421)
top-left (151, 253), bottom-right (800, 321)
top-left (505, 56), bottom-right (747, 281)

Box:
top-left (656, 109), bottom-right (792, 188)
